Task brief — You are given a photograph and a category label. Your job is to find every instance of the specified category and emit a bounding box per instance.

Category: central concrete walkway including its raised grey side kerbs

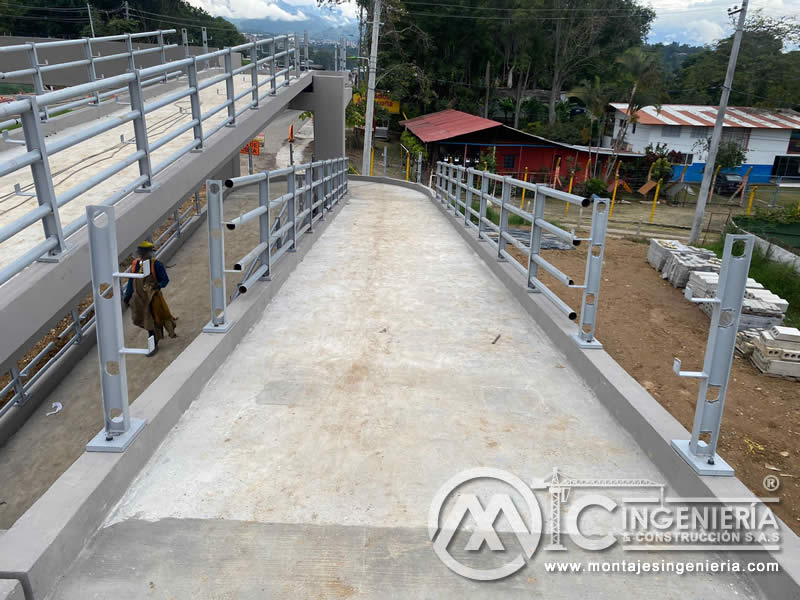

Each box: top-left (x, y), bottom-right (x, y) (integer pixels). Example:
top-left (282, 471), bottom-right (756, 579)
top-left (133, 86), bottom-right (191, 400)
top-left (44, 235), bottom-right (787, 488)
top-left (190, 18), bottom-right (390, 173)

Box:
top-left (0, 178), bottom-right (798, 600)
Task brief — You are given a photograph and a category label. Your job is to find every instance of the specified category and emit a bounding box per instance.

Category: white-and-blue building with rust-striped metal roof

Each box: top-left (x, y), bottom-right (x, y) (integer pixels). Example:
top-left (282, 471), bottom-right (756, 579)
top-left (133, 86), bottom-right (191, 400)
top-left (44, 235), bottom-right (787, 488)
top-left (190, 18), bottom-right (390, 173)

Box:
top-left (604, 103), bottom-right (800, 183)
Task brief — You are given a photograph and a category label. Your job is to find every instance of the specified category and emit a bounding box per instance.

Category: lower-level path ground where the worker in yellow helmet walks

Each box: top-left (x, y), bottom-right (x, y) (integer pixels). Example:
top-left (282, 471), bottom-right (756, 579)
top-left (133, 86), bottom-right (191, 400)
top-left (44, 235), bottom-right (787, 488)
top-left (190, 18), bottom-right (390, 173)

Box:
top-left (0, 110), bottom-right (313, 530)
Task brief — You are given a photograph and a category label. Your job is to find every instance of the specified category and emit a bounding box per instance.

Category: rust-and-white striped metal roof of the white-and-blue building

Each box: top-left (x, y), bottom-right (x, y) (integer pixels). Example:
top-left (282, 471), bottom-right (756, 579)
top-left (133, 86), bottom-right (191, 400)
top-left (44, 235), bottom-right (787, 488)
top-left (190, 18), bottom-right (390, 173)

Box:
top-left (611, 103), bottom-right (800, 129)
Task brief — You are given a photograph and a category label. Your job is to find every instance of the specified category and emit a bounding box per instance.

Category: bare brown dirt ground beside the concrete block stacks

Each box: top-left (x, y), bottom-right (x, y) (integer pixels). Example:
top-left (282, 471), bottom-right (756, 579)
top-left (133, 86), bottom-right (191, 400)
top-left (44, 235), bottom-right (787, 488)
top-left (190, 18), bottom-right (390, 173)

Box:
top-left (506, 239), bottom-right (800, 533)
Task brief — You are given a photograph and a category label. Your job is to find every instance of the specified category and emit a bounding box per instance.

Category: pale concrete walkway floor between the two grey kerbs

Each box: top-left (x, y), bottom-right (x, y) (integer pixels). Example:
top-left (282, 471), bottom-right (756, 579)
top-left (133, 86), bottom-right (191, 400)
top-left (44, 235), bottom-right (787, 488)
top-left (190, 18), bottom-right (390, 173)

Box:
top-left (45, 183), bottom-right (759, 600)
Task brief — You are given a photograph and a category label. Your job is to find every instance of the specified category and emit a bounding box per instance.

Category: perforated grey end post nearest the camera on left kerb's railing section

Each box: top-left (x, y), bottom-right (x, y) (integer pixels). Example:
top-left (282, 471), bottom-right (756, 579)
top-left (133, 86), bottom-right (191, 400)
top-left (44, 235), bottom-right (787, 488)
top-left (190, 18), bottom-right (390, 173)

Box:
top-left (203, 179), bottom-right (232, 333)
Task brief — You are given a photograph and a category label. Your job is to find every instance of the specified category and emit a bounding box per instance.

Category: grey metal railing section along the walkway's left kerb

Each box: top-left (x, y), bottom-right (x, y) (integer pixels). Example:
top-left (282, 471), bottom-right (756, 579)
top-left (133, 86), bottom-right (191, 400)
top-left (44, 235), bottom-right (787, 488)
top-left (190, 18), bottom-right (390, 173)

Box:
top-left (203, 157), bottom-right (348, 333)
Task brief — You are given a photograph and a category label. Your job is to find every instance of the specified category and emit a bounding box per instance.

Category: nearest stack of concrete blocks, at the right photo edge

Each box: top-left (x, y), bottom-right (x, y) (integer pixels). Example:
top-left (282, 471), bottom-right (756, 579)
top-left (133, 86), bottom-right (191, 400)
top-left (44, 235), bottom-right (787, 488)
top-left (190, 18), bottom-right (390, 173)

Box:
top-left (736, 325), bottom-right (800, 379)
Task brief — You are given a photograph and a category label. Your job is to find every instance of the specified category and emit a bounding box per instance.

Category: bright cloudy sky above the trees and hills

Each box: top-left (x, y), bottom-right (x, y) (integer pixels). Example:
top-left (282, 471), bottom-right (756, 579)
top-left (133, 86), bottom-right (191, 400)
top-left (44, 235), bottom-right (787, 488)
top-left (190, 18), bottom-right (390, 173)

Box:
top-left (189, 0), bottom-right (800, 46)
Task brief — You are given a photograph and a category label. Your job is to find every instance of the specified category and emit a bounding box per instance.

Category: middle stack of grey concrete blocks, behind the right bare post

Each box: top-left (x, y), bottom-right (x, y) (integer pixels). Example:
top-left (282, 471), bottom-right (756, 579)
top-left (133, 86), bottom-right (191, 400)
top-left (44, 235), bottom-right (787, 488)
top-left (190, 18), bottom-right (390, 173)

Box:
top-left (686, 271), bottom-right (789, 331)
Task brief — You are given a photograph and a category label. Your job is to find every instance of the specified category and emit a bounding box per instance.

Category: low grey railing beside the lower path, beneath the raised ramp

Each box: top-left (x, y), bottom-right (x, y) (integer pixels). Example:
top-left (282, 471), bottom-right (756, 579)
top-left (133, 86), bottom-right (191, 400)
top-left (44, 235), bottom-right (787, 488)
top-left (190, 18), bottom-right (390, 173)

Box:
top-left (0, 193), bottom-right (201, 417)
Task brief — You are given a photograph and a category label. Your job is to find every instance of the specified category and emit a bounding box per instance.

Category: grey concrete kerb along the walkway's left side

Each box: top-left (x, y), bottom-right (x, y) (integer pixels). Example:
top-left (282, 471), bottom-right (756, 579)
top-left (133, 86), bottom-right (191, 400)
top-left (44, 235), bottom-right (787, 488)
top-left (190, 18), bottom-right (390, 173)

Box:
top-left (0, 193), bottom-right (343, 600)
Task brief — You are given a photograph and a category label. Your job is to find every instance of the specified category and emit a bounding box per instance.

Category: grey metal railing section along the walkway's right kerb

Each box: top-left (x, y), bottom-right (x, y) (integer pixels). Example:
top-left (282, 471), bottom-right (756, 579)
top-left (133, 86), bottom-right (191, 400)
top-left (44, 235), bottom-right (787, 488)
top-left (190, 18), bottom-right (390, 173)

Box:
top-left (434, 162), bottom-right (610, 348)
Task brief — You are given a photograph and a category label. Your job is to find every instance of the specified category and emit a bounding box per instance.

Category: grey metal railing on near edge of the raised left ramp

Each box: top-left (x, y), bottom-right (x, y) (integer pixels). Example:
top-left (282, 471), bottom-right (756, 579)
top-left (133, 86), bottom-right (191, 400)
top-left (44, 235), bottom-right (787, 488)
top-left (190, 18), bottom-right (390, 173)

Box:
top-left (0, 34), bottom-right (300, 285)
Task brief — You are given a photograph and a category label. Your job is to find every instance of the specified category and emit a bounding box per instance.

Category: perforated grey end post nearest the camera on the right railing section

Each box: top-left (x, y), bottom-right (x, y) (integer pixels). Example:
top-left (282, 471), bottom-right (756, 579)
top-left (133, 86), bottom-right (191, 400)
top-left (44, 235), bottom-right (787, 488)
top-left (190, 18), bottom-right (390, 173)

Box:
top-left (575, 195), bottom-right (608, 348)
